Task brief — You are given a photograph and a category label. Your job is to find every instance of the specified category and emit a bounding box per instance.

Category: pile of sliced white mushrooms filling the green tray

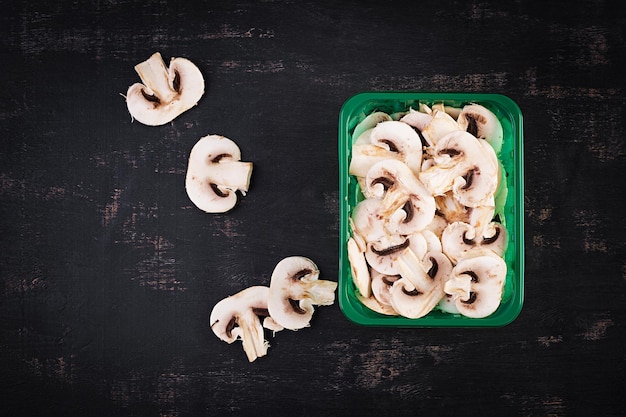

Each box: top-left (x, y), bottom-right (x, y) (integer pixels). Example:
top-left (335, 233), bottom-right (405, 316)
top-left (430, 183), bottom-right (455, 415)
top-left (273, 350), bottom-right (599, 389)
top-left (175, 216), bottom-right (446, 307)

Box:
top-left (347, 104), bottom-right (507, 318)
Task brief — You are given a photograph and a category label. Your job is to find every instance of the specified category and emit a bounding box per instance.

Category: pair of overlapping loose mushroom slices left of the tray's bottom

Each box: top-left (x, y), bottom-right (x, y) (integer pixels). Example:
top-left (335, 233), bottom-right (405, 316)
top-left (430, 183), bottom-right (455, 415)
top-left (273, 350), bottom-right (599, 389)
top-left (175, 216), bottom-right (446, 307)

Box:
top-left (209, 256), bottom-right (337, 362)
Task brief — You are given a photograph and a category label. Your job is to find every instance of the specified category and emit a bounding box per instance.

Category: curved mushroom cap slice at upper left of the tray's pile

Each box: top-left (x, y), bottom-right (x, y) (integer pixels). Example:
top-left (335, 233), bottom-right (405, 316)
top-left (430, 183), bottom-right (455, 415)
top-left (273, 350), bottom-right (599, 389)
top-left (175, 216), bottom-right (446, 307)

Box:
top-left (370, 120), bottom-right (422, 175)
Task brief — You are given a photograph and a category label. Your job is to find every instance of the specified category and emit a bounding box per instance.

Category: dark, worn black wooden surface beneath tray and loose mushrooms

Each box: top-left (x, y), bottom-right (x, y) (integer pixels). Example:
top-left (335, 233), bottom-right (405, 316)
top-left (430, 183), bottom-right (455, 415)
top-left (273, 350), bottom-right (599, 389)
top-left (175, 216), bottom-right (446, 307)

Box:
top-left (0, 0), bottom-right (626, 417)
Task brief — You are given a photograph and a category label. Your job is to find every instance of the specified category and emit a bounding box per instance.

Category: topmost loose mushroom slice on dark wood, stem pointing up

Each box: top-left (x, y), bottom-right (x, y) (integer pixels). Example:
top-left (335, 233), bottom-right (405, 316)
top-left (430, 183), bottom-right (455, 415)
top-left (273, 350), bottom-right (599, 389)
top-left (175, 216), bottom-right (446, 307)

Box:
top-left (126, 52), bottom-right (204, 126)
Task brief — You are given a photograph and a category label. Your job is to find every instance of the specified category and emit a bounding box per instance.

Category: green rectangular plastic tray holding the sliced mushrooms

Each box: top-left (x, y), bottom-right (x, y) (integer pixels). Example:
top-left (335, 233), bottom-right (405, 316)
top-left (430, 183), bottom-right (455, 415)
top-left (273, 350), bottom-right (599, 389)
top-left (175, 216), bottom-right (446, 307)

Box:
top-left (338, 91), bottom-right (524, 327)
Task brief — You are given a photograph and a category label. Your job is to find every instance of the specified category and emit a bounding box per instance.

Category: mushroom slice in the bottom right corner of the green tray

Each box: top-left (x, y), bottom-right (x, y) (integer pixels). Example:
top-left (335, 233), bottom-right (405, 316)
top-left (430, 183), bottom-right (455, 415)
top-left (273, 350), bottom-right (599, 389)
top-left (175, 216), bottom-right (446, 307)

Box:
top-left (444, 250), bottom-right (507, 318)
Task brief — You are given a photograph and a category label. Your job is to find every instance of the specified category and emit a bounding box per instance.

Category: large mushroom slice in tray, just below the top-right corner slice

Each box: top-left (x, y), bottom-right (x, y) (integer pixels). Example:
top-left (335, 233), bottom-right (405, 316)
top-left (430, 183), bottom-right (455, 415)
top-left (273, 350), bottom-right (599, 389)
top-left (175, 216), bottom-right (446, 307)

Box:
top-left (419, 131), bottom-right (499, 207)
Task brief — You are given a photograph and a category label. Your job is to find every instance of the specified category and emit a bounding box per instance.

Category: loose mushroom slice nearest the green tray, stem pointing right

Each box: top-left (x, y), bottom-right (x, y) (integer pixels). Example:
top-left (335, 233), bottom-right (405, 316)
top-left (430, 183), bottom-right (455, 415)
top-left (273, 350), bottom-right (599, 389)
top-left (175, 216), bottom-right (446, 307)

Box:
top-left (267, 256), bottom-right (337, 330)
